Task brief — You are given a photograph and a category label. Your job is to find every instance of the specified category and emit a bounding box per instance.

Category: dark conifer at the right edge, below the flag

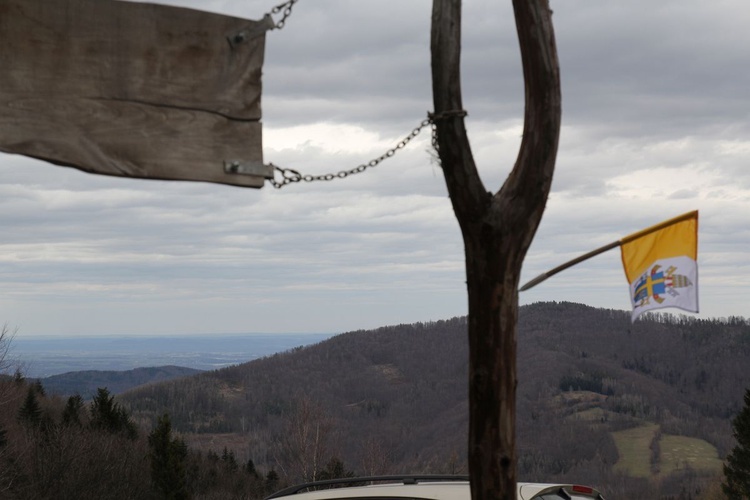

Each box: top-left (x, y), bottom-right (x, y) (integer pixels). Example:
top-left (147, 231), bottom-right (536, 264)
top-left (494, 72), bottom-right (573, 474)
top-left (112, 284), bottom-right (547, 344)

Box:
top-left (721, 389), bottom-right (750, 500)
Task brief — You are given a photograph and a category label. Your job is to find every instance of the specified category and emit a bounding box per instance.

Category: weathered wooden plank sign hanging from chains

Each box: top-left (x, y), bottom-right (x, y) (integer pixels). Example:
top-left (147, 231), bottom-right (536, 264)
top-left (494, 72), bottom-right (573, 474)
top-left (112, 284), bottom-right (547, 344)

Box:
top-left (0, 0), bottom-right (274, 187)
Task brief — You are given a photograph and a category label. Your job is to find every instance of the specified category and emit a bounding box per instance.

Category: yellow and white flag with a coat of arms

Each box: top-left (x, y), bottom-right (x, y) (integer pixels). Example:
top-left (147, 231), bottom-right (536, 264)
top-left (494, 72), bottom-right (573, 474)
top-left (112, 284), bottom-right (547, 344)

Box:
top-left (620, 210), bottom-right (698, 321)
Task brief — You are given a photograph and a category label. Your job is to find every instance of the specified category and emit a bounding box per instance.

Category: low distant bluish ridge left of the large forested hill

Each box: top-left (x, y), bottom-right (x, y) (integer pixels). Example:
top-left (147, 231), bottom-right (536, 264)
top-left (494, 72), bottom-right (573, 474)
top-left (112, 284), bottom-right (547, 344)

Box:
top-left (37, 366), bottom-right (202, 399)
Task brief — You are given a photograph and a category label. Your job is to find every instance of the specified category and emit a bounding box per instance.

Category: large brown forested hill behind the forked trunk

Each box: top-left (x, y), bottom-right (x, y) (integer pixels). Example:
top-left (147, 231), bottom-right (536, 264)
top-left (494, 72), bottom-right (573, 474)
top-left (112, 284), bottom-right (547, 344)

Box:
top-left (123, 303), bottom-right (750, 498)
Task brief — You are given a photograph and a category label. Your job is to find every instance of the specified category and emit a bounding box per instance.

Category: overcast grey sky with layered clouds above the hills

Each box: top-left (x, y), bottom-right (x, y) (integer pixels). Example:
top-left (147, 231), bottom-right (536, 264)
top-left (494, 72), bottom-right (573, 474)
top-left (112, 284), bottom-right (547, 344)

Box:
top-left (0, 0), bottom-right (750, 336)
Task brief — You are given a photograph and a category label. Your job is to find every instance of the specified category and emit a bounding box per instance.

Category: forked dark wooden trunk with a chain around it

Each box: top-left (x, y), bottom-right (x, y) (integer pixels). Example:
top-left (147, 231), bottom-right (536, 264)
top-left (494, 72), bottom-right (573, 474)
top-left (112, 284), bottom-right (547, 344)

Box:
top-left (431, 0), bottom-right (561, 500)
